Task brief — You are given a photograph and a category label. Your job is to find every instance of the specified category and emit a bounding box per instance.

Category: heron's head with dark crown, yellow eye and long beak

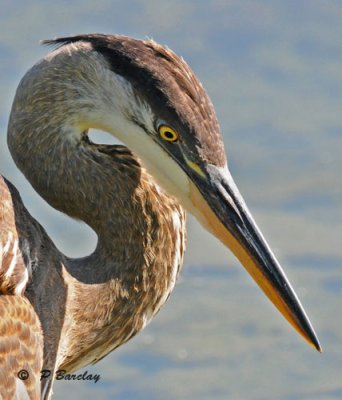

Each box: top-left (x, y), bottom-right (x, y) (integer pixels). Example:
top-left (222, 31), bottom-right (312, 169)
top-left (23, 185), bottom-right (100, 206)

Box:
top-left (47, 35), bottom-right (320, 350)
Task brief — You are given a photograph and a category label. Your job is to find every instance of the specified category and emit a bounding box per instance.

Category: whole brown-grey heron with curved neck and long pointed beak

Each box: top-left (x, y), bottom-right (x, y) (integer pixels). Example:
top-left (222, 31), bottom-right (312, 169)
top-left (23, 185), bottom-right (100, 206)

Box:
top-left (0, 35), bottom-right (320, 399)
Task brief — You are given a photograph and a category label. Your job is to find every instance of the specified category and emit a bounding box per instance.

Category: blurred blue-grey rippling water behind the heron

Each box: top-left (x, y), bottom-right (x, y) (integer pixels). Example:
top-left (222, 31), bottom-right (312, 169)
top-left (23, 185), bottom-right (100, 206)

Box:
top-left (0, 0), bottom-right (342, 400)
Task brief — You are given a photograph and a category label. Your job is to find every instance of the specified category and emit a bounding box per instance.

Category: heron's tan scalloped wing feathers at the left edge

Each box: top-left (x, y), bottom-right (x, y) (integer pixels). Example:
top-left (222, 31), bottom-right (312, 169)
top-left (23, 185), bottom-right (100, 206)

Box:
top-left (0, 175), bottom-right (43, 399)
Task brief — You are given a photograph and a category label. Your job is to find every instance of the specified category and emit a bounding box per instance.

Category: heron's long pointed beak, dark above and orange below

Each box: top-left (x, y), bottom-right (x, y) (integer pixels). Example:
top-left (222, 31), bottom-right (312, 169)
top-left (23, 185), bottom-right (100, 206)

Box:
top-left (190, 165), bottom-right (321, 352)
